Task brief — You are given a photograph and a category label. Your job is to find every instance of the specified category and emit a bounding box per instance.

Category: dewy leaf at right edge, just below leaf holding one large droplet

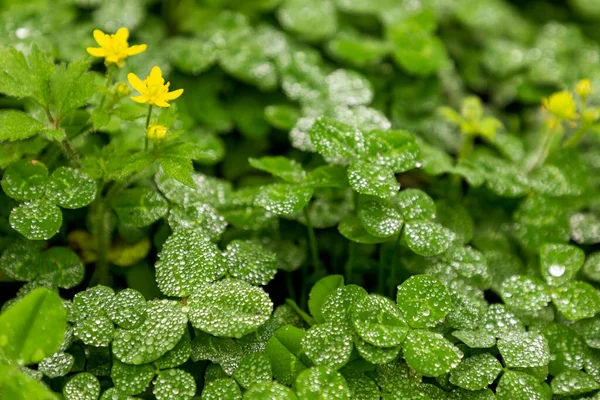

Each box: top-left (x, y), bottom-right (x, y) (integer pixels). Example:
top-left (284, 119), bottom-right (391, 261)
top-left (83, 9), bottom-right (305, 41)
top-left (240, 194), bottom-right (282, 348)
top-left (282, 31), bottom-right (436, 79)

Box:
top-left (552, 281), bottom-right (600, 321)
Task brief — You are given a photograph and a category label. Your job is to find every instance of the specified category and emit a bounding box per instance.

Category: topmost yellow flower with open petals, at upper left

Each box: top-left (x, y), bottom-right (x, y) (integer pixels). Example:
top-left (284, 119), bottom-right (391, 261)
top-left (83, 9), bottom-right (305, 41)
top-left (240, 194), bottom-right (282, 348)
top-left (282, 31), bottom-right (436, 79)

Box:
top-left (87, 28), bottom-right (147, 67)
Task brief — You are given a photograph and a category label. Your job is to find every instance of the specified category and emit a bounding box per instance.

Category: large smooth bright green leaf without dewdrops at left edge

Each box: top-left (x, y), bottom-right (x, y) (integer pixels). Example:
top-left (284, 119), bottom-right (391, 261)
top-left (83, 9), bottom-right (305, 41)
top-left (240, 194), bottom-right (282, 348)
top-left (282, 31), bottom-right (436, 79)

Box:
top-left (0, 288), bottom-right (67, 365)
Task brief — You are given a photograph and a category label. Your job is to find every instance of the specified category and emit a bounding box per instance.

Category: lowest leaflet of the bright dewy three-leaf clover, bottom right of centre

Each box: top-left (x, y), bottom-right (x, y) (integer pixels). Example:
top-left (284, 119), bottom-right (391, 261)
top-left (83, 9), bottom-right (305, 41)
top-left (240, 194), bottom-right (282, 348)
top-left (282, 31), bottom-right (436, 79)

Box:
top-left (402, 330), bottom-right (463, 376)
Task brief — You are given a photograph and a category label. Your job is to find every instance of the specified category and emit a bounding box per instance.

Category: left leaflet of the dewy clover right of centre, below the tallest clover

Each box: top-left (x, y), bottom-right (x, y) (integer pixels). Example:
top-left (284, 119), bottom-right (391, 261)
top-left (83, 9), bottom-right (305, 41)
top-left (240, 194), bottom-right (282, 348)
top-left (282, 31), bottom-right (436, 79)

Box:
top-left (358, 199), bottom-right (403, 238)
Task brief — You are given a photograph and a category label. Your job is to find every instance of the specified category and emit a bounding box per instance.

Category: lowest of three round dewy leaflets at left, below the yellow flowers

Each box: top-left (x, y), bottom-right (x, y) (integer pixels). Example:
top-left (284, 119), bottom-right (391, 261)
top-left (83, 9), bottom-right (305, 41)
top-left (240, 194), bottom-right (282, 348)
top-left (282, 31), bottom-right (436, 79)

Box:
top-left (9, 199), bottom-right (62, 240)
